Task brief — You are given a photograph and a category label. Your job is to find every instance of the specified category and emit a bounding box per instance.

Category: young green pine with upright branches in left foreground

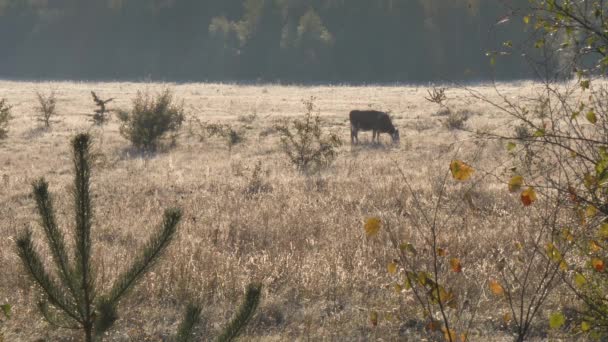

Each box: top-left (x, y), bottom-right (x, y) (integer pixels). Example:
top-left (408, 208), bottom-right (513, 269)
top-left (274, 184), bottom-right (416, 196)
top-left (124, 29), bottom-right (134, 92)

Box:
top-left (17, 134), bottom-right (182, 342)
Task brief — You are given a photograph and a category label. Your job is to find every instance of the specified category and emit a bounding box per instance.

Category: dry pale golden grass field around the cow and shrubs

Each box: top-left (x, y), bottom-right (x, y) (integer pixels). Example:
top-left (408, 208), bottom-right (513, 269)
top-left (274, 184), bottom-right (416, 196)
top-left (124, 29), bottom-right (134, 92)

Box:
top-left (0, 81), bottom-right (560, 341)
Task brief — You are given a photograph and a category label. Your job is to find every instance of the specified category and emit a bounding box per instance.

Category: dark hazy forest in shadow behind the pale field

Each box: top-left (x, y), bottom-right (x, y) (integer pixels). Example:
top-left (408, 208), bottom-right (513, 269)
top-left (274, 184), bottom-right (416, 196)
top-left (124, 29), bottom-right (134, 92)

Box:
top-left (0, 0), bottom-right (534, 84)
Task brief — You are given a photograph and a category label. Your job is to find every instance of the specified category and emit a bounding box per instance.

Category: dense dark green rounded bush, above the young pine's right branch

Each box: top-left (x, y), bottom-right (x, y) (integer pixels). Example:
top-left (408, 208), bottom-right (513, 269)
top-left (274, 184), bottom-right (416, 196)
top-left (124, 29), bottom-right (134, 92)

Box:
top-left (118, 89), bottom-right (184, 152)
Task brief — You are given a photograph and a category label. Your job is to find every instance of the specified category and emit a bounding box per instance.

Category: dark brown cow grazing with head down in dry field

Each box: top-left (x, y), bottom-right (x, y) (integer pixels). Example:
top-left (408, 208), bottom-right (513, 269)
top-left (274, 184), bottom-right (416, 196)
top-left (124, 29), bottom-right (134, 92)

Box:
top-left (349, 110), bottom-right (399, 144)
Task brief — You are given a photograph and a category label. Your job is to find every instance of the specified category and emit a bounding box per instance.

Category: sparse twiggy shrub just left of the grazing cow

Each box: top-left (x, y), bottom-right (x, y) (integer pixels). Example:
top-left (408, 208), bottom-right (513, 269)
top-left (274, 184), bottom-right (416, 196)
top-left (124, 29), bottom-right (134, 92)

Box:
top-left (275, 97), bottom-right (342, 172)
